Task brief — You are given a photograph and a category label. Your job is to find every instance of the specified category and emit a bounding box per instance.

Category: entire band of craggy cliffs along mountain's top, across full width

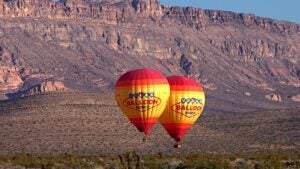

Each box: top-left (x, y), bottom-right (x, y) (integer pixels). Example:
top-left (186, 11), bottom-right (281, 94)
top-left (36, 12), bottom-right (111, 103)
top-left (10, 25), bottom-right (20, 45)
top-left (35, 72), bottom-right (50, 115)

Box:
top-left (0, 0), bottom-right (300, 32)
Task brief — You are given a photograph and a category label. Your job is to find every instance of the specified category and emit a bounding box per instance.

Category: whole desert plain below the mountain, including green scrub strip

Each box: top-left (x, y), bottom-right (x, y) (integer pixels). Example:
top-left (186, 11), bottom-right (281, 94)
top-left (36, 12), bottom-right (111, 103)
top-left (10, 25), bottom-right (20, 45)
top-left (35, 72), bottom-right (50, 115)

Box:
top-left (0, 93), bottom-right (300, 169)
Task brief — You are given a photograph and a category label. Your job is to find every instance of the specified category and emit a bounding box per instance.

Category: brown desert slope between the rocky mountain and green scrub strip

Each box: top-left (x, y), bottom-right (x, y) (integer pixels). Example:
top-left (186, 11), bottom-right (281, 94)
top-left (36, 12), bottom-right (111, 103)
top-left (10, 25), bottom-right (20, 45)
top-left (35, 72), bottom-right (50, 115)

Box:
top-left (0, 92), bottom-right (300, 155)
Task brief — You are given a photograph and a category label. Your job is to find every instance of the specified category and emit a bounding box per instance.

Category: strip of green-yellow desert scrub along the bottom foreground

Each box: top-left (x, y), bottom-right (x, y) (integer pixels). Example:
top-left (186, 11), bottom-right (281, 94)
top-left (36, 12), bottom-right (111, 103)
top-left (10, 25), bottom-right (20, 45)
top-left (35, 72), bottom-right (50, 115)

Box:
top-left (0, 152), bottom-right (300, 169)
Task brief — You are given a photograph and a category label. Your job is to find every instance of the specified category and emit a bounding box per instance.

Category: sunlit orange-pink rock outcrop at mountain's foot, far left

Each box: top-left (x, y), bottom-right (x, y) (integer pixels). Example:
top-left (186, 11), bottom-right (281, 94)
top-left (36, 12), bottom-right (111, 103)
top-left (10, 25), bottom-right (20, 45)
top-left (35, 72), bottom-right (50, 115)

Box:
top-left (0, 47), bottom-right (68, 98)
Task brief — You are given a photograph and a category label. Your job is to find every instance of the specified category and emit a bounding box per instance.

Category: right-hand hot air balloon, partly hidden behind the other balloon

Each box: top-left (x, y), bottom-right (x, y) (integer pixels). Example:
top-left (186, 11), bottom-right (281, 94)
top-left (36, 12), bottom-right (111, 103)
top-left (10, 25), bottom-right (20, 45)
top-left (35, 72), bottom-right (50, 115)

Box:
top-left (159, 76), bottom-right (205, 148)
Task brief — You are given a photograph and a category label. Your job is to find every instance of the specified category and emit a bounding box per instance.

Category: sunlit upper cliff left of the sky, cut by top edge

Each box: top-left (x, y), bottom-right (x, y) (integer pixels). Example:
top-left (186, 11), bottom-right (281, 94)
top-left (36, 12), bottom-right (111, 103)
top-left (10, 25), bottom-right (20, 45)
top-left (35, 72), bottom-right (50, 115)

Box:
top-left (0, 0), bottom-right (163, 22)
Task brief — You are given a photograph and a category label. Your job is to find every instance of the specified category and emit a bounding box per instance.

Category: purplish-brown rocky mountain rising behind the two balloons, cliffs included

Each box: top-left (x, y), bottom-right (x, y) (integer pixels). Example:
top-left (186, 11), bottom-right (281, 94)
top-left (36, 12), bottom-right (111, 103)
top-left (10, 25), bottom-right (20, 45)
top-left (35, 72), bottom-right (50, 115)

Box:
top-left (0, 0), bottom-right (300, 112)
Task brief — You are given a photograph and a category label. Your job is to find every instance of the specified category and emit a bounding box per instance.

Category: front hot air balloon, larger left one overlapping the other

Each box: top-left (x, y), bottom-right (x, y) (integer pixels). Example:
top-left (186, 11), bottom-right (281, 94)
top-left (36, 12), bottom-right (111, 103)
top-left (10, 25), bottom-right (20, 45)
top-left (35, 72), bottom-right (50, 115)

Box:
top-left (115, 69), bottom-right (170, 142)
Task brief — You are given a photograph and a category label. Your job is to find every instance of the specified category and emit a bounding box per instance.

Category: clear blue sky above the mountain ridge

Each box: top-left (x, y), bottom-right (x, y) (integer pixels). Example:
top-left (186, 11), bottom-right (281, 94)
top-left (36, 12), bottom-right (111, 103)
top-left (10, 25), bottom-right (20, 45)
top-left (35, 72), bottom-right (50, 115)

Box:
top-left (160, 0), bottom-right (300, 24)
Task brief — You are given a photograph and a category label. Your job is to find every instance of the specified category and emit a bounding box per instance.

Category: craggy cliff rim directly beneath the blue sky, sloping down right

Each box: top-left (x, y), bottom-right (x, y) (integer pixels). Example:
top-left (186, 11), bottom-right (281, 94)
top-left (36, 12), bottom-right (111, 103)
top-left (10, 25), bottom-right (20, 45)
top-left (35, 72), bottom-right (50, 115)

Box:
top-left (165, 7), bottom-right (300, 33)
